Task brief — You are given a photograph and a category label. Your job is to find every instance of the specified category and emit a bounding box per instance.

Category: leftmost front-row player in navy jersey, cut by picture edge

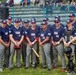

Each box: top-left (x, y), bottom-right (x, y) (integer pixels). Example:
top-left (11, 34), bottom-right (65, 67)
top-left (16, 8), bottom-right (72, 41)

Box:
top-left (0, 20), bottom-right (10, 71)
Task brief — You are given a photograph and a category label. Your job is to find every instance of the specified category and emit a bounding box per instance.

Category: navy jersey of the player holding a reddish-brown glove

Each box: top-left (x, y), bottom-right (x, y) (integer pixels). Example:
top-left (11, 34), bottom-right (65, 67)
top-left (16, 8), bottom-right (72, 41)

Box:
top-left (9, 27), bottom-right (24, 40)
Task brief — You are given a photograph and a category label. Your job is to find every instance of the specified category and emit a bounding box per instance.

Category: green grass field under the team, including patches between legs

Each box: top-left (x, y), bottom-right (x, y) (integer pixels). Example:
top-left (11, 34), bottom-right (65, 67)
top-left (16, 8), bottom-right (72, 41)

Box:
top-left (0, 56), bottom-right (76, 75)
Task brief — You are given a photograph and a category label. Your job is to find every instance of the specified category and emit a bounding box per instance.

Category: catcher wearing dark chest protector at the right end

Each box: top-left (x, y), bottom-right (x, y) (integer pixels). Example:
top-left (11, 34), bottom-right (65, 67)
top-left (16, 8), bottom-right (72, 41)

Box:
top-left (64, 19), bottom-right (76, 62)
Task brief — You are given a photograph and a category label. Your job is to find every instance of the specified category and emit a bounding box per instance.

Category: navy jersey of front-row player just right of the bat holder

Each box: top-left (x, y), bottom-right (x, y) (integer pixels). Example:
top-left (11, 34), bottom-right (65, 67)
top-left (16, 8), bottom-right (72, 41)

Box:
top-left (39, 29), bottom-right (51, 43)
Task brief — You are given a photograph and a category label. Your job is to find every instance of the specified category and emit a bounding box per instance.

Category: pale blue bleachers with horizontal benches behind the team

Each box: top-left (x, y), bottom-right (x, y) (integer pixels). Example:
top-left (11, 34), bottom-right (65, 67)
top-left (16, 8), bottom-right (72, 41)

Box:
top-left (0, 4), bottom-right (76, 25)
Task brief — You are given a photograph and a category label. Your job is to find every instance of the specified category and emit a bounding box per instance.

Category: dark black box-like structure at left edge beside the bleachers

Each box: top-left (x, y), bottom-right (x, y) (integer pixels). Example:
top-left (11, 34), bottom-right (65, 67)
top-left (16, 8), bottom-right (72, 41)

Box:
top-left (0, 7), bottom-right (9, 19)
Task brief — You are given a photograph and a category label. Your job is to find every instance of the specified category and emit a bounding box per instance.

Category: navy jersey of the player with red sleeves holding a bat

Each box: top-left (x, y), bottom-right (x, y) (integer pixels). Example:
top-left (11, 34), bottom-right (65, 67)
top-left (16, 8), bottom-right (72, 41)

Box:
top-left (27, 26), bottom-right (40, 42)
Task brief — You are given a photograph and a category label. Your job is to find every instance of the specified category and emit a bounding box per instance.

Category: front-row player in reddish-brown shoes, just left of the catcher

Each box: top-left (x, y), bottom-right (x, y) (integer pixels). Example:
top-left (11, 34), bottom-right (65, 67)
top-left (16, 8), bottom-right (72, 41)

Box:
top-left (52, 18), bottom-right (66, 72)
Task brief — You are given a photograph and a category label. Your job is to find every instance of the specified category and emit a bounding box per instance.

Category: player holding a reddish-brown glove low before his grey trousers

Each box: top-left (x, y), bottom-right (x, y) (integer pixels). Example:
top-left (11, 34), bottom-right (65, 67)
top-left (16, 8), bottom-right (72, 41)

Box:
top-left (9, 19), bottom-right (24, 70)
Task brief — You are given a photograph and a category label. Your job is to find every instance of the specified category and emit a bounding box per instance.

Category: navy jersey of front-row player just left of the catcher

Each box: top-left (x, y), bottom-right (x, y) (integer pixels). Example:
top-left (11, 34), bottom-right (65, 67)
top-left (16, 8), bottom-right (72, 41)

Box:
top-left (52, 26), bottom-right (64, 42)
